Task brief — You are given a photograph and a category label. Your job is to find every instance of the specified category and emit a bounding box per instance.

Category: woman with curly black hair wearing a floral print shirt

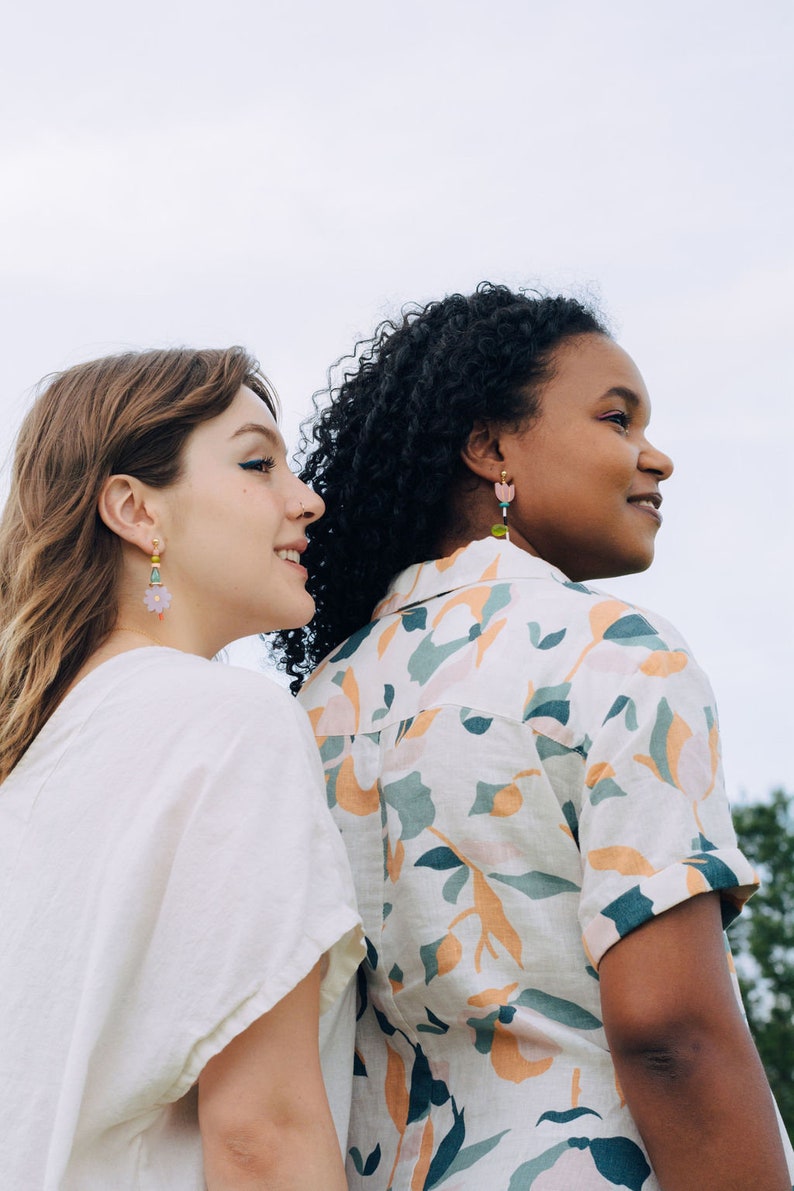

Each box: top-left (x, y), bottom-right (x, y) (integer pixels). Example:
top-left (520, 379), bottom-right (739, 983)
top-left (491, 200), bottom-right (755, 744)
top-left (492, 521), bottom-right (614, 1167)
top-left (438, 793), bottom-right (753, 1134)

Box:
top-left (274, 285), bottom-right (794, 1191)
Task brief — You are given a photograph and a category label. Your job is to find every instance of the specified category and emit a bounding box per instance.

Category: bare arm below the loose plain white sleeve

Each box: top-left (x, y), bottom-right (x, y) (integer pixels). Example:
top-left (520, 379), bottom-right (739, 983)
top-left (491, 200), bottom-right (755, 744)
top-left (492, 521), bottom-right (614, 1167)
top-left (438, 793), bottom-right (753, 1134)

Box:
top-left (199, 965), bottom-right (348, 1191)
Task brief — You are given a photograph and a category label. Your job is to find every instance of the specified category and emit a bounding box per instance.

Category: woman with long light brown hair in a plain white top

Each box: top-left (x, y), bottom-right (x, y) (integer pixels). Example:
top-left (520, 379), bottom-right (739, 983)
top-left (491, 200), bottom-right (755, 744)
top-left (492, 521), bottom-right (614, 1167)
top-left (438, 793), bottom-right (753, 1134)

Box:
top-left (0, 348), bottom-right (361, 1191)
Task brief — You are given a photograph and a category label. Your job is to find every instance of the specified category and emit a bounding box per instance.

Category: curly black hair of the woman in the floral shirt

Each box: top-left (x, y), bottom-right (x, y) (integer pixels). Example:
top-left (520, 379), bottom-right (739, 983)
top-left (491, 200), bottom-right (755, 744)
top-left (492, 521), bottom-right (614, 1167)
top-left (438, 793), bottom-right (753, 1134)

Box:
top-left (274, 282), bottom-right (608, 691)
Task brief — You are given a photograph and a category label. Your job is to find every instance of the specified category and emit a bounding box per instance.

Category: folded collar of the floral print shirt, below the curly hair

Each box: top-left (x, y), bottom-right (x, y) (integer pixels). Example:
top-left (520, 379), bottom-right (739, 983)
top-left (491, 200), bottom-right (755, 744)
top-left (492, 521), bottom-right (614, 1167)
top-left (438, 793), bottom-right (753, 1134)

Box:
top-left (373, 537), bottom-right (570, 621)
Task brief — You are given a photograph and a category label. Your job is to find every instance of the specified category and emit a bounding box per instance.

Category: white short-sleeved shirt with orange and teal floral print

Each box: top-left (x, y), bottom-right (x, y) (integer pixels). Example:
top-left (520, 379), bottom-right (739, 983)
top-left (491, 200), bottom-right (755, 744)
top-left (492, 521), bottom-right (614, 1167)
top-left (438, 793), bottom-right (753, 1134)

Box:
top-left (301, 538), bottom-right (771, 1191)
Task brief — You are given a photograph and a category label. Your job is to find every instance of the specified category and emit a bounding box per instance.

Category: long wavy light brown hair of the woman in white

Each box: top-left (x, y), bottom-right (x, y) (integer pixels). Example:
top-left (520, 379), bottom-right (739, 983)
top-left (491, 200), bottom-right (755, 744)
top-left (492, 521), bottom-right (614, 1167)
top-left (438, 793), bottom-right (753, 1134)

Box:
top-left (0, 348), bottom-right (277, 781)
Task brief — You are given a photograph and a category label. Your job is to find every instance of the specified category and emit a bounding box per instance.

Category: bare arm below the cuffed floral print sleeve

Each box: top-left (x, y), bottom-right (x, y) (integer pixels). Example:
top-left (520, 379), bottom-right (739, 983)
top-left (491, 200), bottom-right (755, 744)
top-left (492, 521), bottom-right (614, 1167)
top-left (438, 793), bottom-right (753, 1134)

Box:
top-left (599, 893), bottom-right (792, 1191)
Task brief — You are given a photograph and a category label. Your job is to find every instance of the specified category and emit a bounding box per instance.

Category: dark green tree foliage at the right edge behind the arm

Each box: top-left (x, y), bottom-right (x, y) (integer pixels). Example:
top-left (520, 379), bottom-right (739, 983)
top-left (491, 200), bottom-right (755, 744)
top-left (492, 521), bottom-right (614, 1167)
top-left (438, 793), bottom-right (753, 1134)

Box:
top-left (730, 790), bottom-right (794, 1136)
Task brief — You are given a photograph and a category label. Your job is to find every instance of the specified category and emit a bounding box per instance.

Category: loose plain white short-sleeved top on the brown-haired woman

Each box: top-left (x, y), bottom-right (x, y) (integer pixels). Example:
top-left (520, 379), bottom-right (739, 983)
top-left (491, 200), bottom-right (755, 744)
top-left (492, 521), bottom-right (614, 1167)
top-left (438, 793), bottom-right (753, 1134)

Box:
top-left (0, 648), bottom-right (362, 1191)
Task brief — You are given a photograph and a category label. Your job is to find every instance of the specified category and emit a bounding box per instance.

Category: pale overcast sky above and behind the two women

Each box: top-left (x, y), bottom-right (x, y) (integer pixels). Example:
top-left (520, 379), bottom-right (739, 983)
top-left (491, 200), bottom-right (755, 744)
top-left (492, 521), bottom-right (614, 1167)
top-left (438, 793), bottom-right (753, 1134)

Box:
top-left (0, 0), bottom-right (794, 797)
